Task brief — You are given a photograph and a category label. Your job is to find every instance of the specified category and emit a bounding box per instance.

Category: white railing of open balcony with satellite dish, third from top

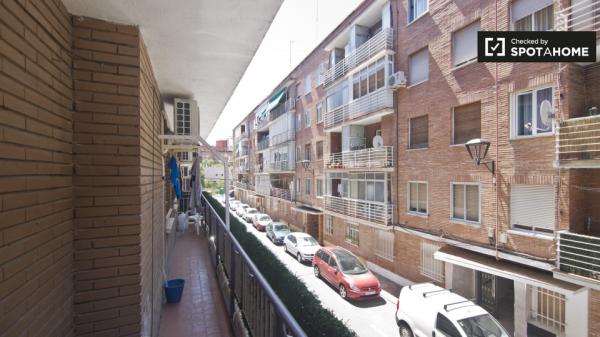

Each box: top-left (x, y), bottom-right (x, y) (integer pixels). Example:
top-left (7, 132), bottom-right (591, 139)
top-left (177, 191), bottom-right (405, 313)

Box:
top-left (325, 146), bottom-right (394, 169)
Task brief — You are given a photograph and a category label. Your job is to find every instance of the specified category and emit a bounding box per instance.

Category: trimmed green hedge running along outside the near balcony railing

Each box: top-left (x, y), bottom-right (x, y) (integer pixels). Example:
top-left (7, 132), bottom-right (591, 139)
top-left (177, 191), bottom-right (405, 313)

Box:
top-left (204, 192), bottom-right (356, 337)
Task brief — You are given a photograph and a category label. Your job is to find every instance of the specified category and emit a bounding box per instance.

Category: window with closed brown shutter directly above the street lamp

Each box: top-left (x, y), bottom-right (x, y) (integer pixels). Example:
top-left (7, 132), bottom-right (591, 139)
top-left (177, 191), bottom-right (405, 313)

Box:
top-left (452, 102), bottom-right (481, 144)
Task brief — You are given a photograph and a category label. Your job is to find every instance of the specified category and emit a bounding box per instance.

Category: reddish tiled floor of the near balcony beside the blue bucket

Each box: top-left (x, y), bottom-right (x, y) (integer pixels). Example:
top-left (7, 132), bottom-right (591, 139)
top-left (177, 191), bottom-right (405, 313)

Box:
top-left (160, 231), bottom-right (233, 337)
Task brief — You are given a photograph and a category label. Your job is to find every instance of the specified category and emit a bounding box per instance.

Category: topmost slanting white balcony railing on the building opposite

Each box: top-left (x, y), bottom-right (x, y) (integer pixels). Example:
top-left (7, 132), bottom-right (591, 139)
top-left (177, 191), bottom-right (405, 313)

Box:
top-left (323, 28), bottom-right (394, 87)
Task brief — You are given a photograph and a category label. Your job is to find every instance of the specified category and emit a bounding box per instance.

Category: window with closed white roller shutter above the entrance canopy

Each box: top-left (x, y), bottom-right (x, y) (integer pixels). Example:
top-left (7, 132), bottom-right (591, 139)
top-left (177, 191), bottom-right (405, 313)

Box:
top-left (510, 184), bottom-right (555, 233)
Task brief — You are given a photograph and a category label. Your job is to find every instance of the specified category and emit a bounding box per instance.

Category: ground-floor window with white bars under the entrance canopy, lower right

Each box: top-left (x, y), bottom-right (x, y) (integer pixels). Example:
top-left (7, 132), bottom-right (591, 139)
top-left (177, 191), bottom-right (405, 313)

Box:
top-left (527, 285), bottom-right (566, 336)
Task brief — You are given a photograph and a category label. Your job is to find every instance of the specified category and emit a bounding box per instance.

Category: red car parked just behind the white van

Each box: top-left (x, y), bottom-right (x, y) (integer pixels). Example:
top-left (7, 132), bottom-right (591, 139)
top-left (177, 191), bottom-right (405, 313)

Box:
top-left (313, 247), bottom-right (381, 300)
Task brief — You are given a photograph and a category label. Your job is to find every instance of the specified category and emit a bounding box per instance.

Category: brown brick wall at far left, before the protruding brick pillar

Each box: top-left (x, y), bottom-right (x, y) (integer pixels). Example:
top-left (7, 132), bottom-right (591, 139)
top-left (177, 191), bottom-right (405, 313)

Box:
top-left (0, 0), bottom-right (73, 337)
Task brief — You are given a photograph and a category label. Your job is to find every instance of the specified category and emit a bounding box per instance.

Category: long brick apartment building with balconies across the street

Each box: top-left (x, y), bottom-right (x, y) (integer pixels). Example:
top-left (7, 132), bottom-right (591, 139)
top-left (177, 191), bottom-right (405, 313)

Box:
top-left (232, 0), bottom-right (600, 336)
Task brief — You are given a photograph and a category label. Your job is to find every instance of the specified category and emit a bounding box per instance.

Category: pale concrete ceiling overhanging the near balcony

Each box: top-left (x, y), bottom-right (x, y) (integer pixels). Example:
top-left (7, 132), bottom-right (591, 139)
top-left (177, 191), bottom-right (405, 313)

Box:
top-left (63, 0), bottom-right (283, 138)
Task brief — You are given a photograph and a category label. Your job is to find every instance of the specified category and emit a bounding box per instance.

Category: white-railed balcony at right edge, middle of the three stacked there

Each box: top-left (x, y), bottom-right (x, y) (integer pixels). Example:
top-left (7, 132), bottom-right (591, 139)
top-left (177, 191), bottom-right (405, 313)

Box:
top-left (556, 115), bottom-right (600, 168)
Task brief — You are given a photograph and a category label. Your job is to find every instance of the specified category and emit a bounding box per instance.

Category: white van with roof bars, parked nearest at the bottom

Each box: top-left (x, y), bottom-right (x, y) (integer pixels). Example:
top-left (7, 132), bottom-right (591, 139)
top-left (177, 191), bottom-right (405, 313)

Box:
top-left (396, 283), bottom-right (510, 337)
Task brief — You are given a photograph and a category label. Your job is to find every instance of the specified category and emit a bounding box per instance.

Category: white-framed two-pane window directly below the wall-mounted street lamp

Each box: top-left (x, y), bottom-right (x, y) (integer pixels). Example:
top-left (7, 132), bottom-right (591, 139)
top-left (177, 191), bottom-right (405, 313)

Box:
top-left (451, 183), bottom-right (479, 223)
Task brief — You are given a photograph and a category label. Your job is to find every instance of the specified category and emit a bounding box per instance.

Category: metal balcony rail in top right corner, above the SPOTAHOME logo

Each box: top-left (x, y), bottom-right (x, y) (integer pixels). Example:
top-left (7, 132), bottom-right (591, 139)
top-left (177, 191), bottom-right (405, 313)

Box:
top-left (554, 0), bottom-right (600, 32)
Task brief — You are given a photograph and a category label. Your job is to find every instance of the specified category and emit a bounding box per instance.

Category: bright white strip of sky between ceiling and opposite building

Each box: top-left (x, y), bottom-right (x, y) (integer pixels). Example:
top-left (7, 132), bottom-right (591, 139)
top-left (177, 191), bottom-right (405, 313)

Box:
top-left (207, 0), bottom-right (362, 144)
